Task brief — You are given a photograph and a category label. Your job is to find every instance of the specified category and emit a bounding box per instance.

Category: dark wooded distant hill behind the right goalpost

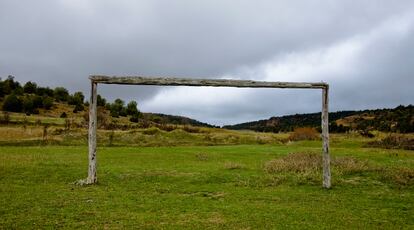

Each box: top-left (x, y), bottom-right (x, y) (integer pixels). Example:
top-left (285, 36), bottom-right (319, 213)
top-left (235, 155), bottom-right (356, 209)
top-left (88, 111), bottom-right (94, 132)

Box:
top-left (223, 105), bottom-right (414, 133)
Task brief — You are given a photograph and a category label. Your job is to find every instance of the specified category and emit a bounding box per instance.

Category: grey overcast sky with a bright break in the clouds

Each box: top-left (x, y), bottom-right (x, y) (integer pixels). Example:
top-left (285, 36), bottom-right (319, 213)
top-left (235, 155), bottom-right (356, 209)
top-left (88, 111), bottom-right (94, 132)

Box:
top-left (0, 0), bottom-right (414, 125)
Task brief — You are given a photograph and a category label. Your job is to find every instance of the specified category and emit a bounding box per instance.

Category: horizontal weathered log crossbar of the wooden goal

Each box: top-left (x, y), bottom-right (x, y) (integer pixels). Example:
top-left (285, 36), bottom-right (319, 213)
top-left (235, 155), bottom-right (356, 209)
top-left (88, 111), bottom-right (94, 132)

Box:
top-left (89, 75), bottom-right (327, 89)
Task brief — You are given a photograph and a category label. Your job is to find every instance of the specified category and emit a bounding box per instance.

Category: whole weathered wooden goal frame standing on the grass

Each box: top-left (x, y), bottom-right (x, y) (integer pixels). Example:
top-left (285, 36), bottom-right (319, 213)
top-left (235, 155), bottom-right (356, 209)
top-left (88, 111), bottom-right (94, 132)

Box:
top-left (81, 75), bottom-right (331, 188)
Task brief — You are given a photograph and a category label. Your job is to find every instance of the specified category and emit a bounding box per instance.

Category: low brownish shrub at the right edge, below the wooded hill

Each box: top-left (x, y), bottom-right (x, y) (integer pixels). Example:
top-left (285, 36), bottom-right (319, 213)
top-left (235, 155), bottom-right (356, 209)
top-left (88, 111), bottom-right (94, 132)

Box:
top-left (366, 134), bottom-right (414, 150)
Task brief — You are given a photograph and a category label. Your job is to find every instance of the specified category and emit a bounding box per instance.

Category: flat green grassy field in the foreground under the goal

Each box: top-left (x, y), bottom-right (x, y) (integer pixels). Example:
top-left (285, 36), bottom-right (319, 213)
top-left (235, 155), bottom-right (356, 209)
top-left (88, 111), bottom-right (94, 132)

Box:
top-left (0, 140), bottom-right (414, 229)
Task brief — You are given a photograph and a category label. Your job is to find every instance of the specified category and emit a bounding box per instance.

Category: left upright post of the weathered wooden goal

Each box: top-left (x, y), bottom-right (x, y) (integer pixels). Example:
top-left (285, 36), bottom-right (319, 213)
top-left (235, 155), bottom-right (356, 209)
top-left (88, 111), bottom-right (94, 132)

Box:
top-left (86, 80), bottom-right (98, 184)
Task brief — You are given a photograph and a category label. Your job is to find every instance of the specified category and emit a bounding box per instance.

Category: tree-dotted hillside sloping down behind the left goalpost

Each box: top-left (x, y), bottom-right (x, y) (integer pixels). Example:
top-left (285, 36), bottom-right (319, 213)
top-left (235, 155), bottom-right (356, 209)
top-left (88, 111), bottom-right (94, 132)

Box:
top-left (0, 75), bottom-right (216, 127)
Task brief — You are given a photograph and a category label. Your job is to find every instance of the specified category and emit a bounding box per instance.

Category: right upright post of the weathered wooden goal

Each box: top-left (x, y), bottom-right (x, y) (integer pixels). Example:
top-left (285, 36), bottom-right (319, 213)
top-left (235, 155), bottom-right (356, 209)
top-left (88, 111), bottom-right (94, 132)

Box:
top-left (322, 85), bottom-right (331, 188)
